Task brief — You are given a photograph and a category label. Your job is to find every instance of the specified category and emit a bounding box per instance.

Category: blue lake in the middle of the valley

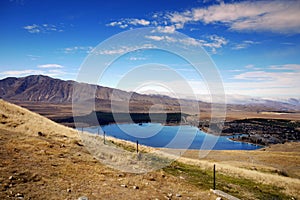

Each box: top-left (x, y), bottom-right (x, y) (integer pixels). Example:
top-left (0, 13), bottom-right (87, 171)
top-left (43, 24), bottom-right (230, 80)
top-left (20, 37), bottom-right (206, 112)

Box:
top-left (80, 123), bottom-right (261, 150)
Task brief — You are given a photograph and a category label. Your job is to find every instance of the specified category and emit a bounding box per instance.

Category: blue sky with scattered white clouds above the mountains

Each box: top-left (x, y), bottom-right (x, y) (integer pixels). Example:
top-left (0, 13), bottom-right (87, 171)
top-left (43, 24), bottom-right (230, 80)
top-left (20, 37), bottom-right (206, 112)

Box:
top-left (0, 0), bottom-right (300, 98)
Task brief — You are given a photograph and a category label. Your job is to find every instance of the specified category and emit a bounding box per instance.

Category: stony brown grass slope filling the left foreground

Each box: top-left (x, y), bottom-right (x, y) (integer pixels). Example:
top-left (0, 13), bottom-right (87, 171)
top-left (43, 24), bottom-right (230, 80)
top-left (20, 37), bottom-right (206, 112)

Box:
top-left (0, 100), bottom-right (216, 199)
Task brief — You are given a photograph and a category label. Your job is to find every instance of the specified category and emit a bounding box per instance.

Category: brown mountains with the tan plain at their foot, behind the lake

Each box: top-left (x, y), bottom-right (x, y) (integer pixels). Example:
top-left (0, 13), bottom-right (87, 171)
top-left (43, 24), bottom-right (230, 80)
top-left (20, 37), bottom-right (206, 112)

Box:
top-left (0, 75), bottom-right (300, 121)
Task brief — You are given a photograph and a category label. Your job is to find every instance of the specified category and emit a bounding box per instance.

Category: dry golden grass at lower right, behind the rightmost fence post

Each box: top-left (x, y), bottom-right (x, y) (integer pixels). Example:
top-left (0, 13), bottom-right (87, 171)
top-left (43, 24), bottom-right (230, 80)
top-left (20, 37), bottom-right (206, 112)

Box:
top-left (172, 146), bottom-right (300, 197)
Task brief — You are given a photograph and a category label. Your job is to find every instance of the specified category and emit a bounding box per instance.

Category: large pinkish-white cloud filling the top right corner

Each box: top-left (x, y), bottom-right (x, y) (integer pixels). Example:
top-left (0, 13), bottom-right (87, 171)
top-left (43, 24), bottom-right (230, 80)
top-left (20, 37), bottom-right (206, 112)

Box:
top-left (167, 0), bottom-right (300, 34)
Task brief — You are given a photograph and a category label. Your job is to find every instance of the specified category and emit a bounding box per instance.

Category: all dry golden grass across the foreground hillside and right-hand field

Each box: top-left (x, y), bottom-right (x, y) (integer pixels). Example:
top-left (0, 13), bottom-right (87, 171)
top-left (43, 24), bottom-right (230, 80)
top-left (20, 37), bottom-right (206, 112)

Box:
top-left (0, 100), bottom-right (300, 199)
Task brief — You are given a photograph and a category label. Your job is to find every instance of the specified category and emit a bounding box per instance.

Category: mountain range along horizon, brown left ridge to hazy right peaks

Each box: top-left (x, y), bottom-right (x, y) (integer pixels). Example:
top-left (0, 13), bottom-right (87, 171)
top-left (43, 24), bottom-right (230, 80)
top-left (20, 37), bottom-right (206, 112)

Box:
top-left (0, 75), bottom-right (300, 112)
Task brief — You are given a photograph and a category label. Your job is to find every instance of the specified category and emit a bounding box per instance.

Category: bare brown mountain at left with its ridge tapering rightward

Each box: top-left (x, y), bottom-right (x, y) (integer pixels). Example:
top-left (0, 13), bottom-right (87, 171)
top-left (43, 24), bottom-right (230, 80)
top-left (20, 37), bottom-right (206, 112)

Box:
top-left (0, 75), bottom-right (195, 112)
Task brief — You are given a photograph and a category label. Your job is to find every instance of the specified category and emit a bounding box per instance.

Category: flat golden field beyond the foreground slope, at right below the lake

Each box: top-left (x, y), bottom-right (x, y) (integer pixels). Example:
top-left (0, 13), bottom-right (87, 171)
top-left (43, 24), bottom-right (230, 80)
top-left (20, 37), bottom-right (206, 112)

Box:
top-left (180, 142), bottom-right (300, 178)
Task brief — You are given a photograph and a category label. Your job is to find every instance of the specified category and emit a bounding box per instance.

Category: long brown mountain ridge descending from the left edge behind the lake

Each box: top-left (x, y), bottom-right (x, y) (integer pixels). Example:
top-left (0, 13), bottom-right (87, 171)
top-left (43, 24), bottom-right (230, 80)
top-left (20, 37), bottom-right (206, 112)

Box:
top-left (0, 75), bottom-right (183, 105)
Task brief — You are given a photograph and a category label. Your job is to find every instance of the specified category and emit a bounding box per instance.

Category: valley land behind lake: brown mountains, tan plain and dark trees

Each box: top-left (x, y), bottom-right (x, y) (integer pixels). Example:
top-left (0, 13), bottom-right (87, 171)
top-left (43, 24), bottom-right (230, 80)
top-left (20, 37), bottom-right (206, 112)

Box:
top-left (0, 75), bottom-right (300, 145)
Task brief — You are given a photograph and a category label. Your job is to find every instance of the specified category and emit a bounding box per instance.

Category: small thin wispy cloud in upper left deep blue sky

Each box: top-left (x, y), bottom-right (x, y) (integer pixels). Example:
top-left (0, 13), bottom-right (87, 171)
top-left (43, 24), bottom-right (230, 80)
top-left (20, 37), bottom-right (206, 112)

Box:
top-left (23, 24), bottom-right (64, 33)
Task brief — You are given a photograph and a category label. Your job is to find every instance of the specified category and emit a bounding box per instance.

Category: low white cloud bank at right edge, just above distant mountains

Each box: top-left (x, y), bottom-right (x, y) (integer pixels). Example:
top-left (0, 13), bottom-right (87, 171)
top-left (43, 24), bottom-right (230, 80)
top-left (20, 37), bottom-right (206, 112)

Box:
top-left (224, 64), bottom-right (300, 97)
